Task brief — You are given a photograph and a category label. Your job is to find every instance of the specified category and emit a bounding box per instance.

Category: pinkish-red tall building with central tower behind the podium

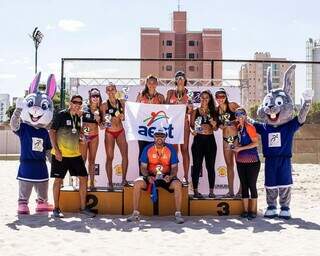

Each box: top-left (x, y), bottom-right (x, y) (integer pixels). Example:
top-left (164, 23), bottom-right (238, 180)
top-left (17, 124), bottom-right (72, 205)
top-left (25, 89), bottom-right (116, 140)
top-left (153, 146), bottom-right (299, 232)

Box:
top-left (140, 11), bottom-right (222, 79)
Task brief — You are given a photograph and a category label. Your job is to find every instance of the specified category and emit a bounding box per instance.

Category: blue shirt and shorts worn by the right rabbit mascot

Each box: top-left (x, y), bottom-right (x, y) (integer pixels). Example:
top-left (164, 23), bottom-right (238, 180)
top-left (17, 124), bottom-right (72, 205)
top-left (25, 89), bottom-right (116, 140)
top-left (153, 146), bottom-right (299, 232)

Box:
top-left (254, 117), bottom-right (301, 188)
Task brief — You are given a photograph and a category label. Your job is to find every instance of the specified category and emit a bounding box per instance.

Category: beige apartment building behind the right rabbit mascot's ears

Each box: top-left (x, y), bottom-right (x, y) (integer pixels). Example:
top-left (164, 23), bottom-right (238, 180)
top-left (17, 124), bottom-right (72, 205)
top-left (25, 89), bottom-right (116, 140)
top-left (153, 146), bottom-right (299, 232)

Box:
top-left (239, 52), bottom-right (295, 109)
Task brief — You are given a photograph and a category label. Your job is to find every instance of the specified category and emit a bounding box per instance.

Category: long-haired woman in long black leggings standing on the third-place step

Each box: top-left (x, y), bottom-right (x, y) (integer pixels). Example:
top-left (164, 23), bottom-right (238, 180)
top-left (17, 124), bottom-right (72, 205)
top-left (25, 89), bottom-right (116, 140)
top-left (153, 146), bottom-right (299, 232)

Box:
top-left (190, 91), bottom-right (217, 198)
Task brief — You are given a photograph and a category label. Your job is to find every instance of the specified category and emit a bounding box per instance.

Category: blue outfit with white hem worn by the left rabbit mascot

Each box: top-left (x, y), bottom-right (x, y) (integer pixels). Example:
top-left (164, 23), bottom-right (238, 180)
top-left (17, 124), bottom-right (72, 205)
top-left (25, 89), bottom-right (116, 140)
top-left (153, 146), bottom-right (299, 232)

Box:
top-left (14, 123), bottom-right (52, 182)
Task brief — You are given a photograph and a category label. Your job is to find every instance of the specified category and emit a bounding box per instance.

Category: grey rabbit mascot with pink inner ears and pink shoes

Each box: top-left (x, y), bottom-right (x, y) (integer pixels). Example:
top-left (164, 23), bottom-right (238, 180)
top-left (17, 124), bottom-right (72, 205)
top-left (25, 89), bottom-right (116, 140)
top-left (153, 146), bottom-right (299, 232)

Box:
top-left (10, 73), bottom-right (56, 214)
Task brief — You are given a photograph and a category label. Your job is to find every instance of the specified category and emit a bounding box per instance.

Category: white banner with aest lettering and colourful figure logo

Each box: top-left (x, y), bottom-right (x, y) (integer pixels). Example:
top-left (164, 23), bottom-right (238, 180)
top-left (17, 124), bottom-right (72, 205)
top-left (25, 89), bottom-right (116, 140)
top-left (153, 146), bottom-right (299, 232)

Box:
top-left (124, 102), bottom-right (186, 144)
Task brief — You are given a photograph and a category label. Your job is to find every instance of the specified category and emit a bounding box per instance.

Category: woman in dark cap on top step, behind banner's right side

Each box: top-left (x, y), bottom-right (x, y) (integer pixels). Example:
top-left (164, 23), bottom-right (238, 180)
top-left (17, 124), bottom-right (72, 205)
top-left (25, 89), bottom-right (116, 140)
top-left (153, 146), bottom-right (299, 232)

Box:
top-left (166, 71), bottom-right (193, 185)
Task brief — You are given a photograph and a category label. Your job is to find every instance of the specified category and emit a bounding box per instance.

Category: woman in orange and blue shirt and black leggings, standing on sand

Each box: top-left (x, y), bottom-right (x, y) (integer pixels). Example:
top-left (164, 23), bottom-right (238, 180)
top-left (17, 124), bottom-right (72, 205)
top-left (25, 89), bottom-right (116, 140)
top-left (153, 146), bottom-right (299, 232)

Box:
top-left (233, 108), bottom-right (260, 219)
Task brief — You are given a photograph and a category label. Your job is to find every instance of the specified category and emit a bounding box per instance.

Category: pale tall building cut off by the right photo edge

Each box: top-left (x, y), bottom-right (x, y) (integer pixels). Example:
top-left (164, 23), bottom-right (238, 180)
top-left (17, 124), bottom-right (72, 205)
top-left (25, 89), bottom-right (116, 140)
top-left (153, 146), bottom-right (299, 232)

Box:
top-left (306, 38), bottom-right (320, 101)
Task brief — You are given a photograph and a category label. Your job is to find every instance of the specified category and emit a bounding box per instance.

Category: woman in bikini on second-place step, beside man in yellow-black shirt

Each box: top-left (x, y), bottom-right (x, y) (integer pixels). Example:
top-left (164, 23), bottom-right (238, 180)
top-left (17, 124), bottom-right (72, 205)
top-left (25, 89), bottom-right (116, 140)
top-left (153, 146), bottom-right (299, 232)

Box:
top-left (80, 88), bottom-right (102, 190)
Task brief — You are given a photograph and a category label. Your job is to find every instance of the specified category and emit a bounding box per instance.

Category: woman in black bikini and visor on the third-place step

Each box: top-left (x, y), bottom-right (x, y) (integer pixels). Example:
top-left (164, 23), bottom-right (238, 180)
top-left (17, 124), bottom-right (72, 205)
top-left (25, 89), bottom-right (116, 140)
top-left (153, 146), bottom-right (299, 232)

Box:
top-left (215, 88), bottom-right (240, 197)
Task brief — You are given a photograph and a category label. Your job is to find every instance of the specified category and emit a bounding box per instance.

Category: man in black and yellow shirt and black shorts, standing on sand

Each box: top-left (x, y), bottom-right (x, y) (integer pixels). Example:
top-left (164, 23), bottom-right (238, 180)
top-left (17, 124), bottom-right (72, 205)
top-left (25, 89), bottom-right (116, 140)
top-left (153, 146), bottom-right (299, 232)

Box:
top-left (49, 95), bottom-right (95, 218)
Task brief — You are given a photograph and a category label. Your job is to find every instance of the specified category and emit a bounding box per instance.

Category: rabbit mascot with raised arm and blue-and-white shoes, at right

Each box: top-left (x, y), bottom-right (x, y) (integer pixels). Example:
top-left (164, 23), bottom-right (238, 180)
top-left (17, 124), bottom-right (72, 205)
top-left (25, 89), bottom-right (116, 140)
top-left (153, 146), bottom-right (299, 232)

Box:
top-left (254, 65), bottom-right (313, 219)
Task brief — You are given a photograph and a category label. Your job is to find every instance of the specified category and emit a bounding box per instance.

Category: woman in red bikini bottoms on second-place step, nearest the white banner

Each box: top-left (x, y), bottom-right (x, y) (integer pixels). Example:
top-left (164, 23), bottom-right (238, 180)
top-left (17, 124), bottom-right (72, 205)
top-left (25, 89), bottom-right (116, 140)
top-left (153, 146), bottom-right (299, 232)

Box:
top-left (101, 83), bottom-right (128, 190)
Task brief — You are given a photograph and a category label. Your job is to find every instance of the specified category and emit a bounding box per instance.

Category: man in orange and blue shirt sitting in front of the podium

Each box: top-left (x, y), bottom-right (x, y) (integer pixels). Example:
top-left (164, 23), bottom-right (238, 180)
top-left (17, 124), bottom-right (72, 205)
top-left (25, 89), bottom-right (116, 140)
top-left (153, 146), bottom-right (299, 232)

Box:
top-left (127, 128), bottom-right (184, 224)
